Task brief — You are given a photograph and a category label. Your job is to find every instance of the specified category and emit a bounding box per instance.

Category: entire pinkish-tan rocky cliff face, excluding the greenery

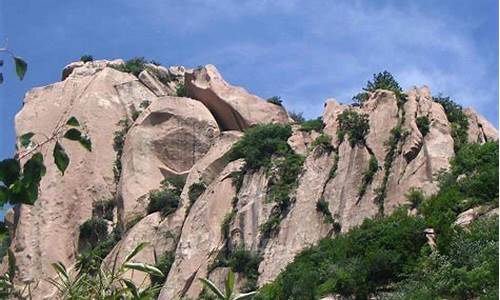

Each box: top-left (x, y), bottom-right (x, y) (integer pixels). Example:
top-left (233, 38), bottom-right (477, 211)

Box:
top-left (6, 60), bottom-right (498, 299)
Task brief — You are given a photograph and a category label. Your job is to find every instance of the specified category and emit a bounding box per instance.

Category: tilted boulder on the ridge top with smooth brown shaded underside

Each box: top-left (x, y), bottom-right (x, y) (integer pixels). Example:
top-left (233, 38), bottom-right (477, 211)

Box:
top-left (185, 65), bottom-right (288, 130)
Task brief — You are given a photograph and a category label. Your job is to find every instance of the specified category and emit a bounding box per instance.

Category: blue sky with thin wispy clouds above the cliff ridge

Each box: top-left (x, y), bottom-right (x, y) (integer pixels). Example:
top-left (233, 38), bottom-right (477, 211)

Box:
top-left (0, 0), bottom-right (498, 164)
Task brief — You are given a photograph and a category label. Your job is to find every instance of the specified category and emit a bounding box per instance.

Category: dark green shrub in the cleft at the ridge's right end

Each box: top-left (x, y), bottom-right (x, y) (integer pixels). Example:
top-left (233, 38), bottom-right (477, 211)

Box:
top-left (432, 95), bottom-right (469, 153)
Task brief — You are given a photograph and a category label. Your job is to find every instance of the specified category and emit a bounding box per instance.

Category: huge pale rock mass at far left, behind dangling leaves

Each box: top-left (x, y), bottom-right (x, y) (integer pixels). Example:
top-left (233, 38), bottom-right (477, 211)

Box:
top-left (11, 63), bottom-right (147, 299)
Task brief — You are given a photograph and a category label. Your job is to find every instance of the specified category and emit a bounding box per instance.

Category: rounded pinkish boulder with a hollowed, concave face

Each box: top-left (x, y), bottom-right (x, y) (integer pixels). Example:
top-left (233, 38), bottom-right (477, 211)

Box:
top-left (118, 96), bottom-right (219, 224)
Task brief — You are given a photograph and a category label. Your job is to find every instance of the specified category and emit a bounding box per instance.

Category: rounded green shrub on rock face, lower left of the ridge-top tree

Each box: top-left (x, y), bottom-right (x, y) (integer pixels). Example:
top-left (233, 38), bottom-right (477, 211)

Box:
top-left (337, 109), bottom-right (370, 147)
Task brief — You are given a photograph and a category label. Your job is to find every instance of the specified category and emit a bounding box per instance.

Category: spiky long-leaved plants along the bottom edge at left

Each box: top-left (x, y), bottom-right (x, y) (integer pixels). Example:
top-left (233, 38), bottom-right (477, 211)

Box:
top-left (48, 243), bottom-right (165, 300)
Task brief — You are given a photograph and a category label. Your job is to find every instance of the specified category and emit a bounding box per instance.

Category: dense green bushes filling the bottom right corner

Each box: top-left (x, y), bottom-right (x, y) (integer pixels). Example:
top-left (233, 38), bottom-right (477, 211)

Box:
top-left (391, 217), bottom-right (498, 299)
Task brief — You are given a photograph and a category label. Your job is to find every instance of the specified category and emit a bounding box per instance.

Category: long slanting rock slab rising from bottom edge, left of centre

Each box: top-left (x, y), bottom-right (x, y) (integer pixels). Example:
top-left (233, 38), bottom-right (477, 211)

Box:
top-left (159, 161), bottom-right (242, 300)
